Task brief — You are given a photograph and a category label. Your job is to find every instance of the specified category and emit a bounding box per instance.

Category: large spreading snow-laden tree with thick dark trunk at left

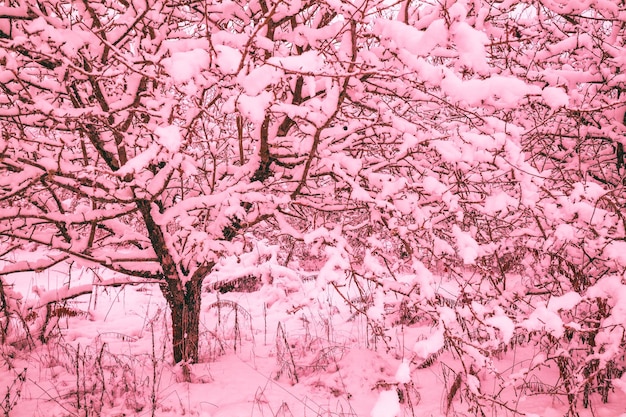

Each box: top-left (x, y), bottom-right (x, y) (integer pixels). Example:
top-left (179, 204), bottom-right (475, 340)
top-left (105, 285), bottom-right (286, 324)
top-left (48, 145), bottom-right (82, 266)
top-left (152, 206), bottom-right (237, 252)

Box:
top-left (0, 1), bottom-right (434, 362)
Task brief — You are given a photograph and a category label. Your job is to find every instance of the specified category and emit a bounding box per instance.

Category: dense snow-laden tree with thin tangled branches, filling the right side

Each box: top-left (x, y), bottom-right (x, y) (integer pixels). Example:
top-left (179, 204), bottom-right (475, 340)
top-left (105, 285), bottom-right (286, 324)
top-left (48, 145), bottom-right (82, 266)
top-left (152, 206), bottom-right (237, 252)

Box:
top-left (334, 1), bottom-right (626, 415)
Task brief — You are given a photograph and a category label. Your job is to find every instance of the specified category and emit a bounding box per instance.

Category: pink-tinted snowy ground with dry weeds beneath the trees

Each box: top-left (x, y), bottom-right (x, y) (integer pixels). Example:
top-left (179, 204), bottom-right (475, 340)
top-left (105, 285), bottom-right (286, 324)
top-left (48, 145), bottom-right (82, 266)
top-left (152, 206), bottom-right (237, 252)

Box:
top-left (0, 266), bottom-right (626, 417)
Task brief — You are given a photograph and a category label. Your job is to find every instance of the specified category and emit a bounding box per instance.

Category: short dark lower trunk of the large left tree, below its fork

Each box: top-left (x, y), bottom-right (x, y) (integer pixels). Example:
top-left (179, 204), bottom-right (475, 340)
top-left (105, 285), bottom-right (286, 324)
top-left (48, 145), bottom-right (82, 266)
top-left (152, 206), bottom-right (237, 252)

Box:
top-left (161, 279), bottom-right (202, 363)
